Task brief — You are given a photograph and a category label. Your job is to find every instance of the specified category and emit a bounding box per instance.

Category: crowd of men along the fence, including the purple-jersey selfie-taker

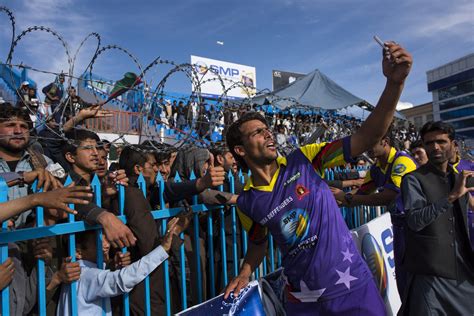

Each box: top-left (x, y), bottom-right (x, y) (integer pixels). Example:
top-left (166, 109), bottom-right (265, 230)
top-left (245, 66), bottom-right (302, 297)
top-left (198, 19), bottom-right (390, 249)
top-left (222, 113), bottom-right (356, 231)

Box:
top-left (0, 42), bottom-right (474, 315)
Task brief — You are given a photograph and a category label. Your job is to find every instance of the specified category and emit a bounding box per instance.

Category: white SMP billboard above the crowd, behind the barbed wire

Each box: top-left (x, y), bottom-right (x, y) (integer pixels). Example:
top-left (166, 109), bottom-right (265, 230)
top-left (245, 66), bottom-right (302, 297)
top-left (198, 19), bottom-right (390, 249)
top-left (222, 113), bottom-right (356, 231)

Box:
top-left (191, 55), bottom-right (257, 98)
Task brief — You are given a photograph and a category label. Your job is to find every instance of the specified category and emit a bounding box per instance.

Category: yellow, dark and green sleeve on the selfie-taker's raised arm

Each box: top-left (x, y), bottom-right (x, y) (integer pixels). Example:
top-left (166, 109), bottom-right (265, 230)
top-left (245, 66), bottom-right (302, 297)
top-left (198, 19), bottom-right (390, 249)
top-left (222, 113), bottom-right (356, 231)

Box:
top-left (300, 136), bottom-right (352, 176)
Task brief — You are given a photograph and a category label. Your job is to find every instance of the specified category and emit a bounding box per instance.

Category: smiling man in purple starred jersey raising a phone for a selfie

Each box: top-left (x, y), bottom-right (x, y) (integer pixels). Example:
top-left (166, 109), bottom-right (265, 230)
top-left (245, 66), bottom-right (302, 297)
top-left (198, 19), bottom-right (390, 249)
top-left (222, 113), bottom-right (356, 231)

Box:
top-left (225, 42), bottom-right (412, 315)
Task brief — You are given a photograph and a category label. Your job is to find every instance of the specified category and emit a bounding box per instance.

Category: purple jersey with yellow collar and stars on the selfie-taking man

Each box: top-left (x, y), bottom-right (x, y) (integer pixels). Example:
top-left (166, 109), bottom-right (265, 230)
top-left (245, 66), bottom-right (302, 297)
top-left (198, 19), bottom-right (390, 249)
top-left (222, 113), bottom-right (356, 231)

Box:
top-left (237, 137), bottom-right (372, 302)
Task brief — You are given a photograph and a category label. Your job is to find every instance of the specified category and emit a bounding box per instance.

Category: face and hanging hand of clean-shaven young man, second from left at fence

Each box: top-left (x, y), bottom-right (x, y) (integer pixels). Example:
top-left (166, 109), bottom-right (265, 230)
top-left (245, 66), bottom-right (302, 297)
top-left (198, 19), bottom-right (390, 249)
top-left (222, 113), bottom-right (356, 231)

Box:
top-left (63, 129), bottom-right (136, 248)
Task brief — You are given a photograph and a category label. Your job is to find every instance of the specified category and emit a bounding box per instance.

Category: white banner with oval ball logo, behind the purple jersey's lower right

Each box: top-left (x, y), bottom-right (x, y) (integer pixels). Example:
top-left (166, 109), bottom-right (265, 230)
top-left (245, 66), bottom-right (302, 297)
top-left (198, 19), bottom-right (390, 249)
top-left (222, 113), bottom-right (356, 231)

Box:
top-left (352, 213), bottom-right (401, 315)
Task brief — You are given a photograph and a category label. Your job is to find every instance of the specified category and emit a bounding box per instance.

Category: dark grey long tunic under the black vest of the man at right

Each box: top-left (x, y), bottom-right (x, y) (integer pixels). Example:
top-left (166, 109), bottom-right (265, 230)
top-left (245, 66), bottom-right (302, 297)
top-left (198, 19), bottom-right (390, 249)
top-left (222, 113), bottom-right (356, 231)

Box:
top-left (402, 167), bottom-right (474, 315)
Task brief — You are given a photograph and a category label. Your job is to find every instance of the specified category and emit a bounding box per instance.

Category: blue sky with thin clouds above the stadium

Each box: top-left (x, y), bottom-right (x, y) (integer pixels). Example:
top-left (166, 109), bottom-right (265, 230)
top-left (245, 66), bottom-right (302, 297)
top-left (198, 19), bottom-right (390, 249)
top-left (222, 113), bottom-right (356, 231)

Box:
top-left (0, 0), bottom-right (474, 105)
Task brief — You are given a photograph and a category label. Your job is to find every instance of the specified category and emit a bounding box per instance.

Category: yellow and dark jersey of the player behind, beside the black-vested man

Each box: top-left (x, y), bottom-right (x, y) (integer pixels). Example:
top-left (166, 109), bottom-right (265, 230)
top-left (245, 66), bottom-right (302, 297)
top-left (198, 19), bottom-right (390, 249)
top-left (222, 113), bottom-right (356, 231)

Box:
top-left (357, 147), bottom-right (417, 194)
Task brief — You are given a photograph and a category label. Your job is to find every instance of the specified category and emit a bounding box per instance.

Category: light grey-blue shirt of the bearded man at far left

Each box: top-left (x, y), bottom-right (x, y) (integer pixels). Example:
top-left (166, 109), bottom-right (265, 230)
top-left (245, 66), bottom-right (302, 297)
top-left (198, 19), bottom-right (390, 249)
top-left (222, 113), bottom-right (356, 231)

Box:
top-left (0, 150), bottom-right (53, 227)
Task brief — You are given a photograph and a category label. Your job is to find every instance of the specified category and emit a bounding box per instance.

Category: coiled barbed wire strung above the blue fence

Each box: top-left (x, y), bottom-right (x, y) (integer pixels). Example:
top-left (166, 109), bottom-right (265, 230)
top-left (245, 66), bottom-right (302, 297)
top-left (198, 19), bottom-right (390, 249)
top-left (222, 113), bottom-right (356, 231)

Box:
top-left (4, 6), bottom-right (462, 160)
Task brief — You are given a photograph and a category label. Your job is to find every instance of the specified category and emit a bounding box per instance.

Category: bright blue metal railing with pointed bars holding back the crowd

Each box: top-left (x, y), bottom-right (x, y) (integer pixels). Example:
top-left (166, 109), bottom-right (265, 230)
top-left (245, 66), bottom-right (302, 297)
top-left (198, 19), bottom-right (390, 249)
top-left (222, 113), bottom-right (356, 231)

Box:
top-left (0, 170), bottom-right (377, 316)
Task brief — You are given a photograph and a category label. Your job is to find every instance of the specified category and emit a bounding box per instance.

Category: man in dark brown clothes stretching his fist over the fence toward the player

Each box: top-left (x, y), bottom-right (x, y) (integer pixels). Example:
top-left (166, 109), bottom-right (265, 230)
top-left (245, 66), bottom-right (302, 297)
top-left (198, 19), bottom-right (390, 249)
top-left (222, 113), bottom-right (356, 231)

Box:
top-left (114, 142), bottom-right (224, 315)
